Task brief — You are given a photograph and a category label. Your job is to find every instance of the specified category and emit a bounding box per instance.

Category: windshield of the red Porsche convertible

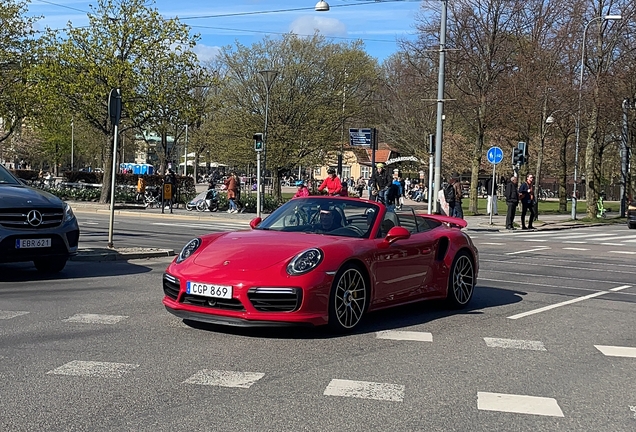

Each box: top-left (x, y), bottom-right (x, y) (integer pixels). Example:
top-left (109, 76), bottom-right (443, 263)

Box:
top-left (258, 197), bottom-right (379, 238)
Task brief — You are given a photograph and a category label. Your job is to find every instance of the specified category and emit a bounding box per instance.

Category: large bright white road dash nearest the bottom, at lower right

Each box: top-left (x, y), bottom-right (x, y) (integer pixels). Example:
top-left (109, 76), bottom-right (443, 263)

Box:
top-left (477, 392), bottom-right (563, 417)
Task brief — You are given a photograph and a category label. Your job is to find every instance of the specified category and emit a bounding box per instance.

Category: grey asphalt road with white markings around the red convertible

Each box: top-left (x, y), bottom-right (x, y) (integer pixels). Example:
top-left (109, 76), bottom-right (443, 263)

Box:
top-left (0, 219), bottom-right (636, 431)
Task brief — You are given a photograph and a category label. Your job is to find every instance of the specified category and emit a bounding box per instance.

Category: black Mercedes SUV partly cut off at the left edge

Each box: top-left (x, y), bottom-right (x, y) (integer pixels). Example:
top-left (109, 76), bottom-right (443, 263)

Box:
top-left (0, 165), bottom-right (79, 273)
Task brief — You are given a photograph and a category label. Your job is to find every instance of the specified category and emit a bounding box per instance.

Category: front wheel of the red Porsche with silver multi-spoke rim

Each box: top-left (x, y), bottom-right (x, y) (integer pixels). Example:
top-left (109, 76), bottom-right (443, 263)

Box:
top-left (329, 265), bottom-right (368, 332)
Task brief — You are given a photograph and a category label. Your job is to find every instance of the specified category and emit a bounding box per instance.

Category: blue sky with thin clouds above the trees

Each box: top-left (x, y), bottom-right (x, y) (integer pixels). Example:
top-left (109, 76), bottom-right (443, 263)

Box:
top-left (29, 0), bottom-right (428, 61)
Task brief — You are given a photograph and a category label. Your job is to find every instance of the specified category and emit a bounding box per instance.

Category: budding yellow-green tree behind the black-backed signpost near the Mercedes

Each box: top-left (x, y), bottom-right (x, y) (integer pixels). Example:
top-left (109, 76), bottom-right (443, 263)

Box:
top-left (39, 0), bottom-right (197, 202)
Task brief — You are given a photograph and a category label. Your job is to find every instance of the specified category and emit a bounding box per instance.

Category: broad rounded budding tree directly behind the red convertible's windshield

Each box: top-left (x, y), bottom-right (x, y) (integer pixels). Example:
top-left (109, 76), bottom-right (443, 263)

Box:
top-left (215, 34), bottom-right (378, 198)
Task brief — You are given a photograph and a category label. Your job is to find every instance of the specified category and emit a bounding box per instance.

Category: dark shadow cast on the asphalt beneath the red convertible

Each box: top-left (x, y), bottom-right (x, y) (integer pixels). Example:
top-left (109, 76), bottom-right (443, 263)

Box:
top-left (184, 286), bottom-right (527, 339)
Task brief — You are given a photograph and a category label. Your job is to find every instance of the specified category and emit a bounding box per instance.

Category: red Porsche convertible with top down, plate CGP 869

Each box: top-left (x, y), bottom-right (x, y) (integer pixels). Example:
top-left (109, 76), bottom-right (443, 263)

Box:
top-left (163, 196), bottom-right (479, 331)
